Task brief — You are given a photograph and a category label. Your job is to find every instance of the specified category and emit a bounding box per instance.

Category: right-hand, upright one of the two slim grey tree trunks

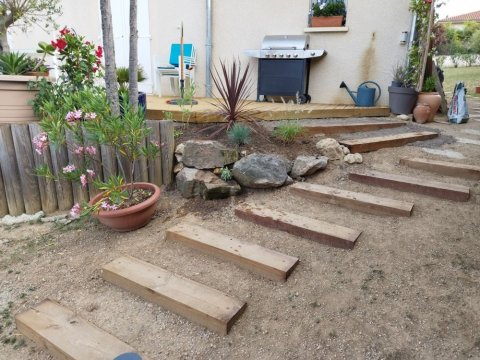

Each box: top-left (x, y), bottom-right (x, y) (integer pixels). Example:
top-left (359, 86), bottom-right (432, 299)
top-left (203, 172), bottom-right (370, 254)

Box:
top-left (128, 0), bottom-right (138, 109)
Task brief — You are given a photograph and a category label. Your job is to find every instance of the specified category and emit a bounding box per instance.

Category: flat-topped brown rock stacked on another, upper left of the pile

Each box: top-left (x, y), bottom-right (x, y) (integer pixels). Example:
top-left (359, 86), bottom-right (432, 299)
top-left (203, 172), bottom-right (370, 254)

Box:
top-left (182, 140), bottom-right (238, 169)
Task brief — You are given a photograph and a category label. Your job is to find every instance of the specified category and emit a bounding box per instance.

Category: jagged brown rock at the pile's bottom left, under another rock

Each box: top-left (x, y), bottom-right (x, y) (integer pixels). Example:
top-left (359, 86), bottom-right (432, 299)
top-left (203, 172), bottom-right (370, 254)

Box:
top-left (176, 168), bottom-right (241, 200)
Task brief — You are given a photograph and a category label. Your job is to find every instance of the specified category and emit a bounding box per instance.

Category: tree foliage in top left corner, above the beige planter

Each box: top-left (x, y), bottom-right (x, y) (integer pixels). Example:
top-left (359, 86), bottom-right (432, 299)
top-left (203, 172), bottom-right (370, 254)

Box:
top-left (0, 0), bottom-right (62, 52)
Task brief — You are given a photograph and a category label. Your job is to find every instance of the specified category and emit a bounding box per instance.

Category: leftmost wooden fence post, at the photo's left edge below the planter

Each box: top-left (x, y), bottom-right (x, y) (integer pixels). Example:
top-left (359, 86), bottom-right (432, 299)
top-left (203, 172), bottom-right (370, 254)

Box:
top-left (0, 125), bottom-right (25, 216)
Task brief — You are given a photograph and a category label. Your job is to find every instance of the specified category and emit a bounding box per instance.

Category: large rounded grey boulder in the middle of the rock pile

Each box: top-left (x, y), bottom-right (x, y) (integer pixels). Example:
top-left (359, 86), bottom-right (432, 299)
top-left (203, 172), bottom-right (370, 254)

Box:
top-left (233, 154), bottom-right (292, 189)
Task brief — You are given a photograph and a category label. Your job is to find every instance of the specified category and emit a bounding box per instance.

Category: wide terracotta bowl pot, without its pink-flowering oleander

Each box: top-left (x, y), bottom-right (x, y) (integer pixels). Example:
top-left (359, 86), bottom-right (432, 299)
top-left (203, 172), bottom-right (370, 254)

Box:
top-left (89, 183), bottom-right (160, 231)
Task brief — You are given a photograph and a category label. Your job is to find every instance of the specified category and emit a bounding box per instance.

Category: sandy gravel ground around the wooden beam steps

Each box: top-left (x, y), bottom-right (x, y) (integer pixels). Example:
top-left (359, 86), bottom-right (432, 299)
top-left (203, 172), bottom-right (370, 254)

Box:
top-left (0, 98), bottom-right (480, 360)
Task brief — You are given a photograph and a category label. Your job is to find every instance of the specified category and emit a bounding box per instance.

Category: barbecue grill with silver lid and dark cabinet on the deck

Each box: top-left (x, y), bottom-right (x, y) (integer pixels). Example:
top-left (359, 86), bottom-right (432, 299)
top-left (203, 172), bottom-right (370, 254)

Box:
top-left (245, 35), bottom-right (327, 103)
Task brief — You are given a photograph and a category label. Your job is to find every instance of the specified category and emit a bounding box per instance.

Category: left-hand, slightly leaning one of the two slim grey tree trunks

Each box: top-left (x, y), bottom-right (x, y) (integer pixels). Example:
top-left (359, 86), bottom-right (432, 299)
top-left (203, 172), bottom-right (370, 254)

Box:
top-left (100, 0), bottom-right (120, 116)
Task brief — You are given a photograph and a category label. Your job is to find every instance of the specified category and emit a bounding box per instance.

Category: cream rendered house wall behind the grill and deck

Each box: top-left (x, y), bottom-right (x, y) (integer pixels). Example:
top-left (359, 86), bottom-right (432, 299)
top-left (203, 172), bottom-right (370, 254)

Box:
top-left (10, 0), bottom-right (412, 105)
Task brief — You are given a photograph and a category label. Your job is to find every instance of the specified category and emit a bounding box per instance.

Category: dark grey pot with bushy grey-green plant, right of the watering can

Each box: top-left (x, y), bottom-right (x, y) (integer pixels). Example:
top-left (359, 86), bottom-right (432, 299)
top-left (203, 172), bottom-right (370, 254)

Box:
top-left (388, 65), bottom-right (418, 114)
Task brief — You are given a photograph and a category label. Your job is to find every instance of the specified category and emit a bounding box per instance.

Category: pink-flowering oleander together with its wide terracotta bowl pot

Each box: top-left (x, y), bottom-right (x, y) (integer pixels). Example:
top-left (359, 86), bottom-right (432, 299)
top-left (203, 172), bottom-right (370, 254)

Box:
top-left (33, 87), bottom-right (160, 231)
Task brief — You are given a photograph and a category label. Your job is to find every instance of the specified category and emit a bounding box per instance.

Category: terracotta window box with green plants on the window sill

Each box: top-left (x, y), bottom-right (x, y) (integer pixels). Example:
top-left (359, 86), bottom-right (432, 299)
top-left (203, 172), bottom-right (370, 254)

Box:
top-left (310, 0), bottom-right (346, 27)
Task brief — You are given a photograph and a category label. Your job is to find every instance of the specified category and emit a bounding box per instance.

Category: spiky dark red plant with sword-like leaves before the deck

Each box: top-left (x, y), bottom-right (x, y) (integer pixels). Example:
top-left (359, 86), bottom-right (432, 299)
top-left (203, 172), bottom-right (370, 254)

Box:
top-left (212, 59), bottom-right (254, 131)
